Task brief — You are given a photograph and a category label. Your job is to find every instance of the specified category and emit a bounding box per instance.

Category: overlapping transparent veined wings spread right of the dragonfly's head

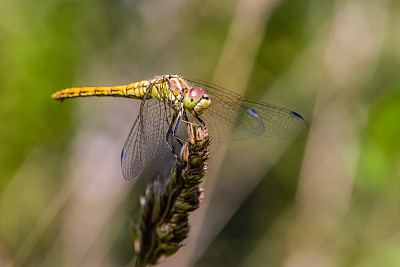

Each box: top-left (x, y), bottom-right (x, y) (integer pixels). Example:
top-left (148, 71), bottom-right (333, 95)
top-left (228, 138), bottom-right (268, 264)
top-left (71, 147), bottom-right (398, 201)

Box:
top-left (186, 78), bottom-right (308, 142)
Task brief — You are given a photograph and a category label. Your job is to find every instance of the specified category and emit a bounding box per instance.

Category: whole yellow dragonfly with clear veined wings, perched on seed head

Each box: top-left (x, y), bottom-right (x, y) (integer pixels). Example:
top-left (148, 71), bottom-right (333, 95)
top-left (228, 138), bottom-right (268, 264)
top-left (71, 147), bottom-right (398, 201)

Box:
top-left (51, 75), bottom-right (308, 181)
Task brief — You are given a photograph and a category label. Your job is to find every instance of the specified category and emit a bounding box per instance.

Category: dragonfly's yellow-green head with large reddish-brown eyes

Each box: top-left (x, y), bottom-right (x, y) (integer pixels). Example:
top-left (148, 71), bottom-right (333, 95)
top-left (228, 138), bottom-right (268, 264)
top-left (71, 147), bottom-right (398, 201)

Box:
top-left (183, 87), bottom-right (211, 116)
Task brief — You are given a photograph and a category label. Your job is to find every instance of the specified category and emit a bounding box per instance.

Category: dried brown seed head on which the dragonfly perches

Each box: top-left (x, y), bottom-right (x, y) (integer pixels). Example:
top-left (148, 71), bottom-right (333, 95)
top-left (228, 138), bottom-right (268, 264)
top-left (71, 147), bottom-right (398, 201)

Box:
top-left (132, 125), bottom-right (210, 266)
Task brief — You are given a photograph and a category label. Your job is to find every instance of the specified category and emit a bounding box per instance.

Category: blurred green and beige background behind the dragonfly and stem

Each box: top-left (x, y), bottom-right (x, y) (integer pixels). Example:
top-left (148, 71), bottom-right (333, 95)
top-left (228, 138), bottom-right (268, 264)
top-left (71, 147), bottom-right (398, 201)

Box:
top-left (0, 0), bottom-right (400, 266)
